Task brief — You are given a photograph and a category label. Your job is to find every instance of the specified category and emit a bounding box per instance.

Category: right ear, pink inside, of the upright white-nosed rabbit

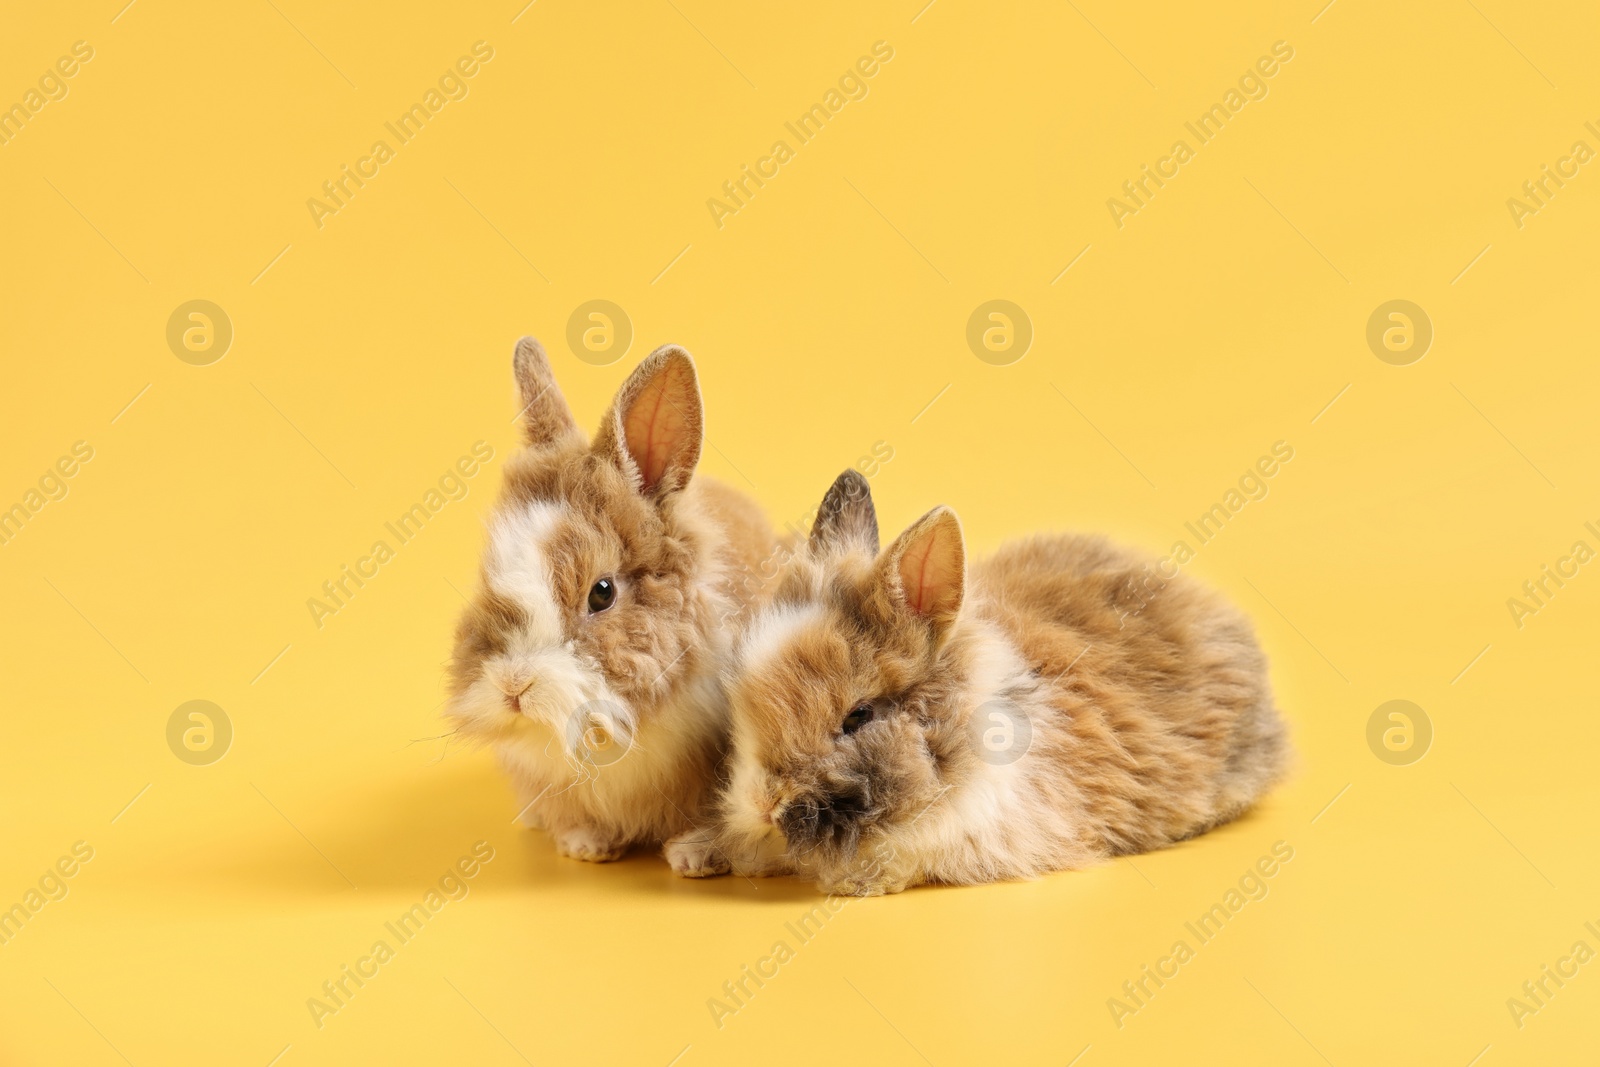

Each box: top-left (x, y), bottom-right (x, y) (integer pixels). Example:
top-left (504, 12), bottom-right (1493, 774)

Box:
top-left (595, 344), bottom-right (706, 501)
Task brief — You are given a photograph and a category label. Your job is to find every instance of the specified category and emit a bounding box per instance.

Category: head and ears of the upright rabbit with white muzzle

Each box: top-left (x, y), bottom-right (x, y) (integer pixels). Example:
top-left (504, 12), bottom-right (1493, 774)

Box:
top-left (446, 338), bottom-right (726, 777)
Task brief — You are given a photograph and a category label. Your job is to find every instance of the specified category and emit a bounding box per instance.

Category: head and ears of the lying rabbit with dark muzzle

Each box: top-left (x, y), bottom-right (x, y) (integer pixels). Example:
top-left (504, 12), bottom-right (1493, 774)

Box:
top-left (722, 470), bottom-right (966, 870)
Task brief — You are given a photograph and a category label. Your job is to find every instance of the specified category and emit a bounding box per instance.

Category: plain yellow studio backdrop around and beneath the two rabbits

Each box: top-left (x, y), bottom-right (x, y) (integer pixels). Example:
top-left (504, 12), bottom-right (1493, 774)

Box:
top-left (0, 0), bottom-right (1600, 1067)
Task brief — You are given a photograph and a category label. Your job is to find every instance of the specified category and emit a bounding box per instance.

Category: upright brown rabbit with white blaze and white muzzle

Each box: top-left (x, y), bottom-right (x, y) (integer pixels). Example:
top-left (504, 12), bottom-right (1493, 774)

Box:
top-left (445, 338), bottom-right (774, 872)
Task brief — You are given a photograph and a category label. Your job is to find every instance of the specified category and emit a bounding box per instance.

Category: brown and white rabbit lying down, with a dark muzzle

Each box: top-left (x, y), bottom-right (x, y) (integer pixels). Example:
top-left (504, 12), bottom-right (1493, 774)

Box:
top-left (698, 470), bottom-right (1290, 896)
